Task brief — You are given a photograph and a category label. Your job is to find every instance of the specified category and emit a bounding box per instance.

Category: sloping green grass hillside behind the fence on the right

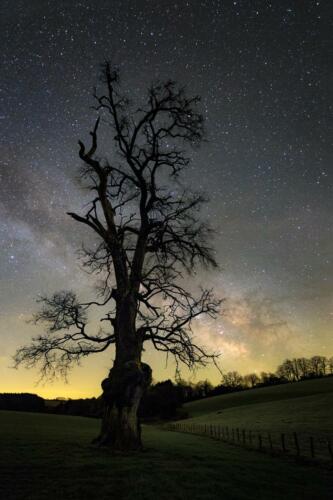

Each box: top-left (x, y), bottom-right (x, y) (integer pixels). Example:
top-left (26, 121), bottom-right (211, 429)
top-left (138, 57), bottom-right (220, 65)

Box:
top-left (185, 377), bottom-right (333, 437)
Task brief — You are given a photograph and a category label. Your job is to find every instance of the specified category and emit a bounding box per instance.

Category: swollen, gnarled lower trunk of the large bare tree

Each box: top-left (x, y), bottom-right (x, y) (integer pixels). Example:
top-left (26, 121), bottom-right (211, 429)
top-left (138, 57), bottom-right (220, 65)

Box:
top-left (94, 361), bottom-right (151, 451)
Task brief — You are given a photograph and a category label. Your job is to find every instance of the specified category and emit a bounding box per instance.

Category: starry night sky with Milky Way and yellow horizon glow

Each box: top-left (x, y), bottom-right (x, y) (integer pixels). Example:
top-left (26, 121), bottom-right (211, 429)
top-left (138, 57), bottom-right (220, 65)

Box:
top-left (0, 0), bottom-right (333, 397)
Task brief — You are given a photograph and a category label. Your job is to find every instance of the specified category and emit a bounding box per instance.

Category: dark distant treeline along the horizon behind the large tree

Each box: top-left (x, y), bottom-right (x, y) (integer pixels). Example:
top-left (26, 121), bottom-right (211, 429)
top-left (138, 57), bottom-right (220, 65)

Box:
top-left (0, 356), bottom-right (333, 421)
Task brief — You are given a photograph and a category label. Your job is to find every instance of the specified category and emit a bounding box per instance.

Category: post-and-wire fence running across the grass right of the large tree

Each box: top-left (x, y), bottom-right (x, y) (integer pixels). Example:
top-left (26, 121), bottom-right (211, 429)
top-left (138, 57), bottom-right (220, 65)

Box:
top-left (165, 422), bottom-right (333, 462)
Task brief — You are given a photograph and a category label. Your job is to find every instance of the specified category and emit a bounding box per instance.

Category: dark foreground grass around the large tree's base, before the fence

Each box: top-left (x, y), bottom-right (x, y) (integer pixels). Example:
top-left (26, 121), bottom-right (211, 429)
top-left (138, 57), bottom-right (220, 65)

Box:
top-left (0, 412), bottom-right (333, 500)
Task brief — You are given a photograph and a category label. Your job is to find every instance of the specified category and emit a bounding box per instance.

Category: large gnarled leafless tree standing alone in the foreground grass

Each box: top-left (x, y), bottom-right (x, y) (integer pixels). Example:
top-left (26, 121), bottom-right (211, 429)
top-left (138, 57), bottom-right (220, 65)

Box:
top-left (15, 62), bottom-right (221, 449)
